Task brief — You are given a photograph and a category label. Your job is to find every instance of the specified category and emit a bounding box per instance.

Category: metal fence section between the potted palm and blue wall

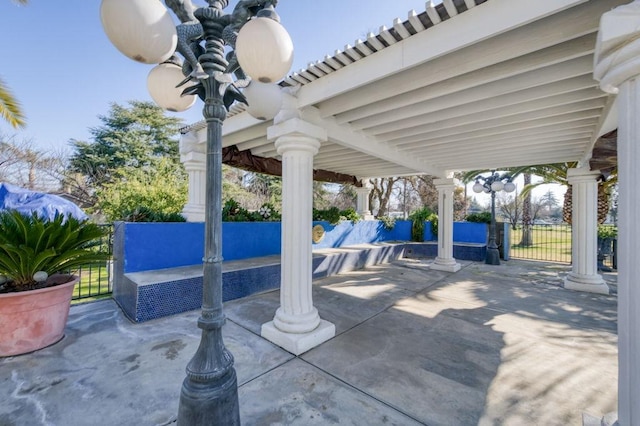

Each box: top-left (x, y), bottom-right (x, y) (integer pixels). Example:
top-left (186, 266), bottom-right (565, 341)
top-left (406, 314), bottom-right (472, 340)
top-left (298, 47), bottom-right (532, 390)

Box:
top-left (73, 224), bottom-right (113, 302)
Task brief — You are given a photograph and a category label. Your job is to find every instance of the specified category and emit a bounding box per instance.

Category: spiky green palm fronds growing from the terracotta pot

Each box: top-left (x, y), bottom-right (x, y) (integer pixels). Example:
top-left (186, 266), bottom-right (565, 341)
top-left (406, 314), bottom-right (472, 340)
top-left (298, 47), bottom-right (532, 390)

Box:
top-left (0, 210), bottom-right (108, 291)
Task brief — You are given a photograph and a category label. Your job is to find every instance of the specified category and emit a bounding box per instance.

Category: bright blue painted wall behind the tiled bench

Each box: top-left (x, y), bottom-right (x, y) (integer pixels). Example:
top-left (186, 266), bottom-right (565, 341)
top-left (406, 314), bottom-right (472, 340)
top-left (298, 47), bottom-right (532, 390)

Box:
top-left (118, 220), bottom-right (487, 273)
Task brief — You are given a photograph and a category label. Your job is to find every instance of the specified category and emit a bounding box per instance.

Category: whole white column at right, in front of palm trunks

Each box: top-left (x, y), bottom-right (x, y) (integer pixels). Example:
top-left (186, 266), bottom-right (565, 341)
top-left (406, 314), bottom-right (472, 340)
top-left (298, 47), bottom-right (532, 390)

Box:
top-left (564, 167), bottom-right (609, 294)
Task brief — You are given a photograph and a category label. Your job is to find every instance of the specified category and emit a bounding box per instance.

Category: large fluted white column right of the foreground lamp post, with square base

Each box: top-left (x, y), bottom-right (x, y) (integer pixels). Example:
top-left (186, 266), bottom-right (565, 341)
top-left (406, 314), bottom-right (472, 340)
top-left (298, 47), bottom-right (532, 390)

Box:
top-left (261, 118), bottom-right (335, 355)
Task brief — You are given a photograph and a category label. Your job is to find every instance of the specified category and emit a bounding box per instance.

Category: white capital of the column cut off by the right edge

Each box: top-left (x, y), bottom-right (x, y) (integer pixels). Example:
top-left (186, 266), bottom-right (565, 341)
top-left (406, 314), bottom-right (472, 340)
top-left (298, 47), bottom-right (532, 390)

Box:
top-left (593, 0), bottom-right (640, 94)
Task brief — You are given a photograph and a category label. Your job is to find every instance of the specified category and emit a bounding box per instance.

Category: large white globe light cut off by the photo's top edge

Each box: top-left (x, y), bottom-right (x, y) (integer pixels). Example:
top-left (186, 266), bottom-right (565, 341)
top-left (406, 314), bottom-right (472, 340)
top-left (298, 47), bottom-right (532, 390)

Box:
top-left (100, 0), bottom-right (178, 64)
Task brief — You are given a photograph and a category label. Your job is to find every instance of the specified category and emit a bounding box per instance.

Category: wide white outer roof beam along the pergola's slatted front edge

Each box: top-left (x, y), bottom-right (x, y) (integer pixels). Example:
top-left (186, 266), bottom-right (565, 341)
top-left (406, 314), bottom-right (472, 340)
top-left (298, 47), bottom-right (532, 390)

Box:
top-left (299, 0), bottom-right (619, 115)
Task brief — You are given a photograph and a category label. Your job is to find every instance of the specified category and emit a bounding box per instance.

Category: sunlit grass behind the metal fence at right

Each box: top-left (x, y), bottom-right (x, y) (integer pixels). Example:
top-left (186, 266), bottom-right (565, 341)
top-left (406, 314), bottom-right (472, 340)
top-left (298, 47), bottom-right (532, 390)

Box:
top-left (510, 224), bottom-right (571, 263)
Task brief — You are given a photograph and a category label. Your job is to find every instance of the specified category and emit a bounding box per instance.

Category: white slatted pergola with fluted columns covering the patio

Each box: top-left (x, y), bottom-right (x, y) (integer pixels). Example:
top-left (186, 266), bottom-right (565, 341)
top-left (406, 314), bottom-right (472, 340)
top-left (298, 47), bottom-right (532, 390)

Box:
top-left (181, 0), bottom-right (640, 424)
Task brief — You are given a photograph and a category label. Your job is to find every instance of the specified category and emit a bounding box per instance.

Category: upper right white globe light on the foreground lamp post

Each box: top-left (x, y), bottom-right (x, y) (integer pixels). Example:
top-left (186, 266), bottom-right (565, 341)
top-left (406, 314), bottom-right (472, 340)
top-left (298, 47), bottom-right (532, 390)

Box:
top-left (236, 18), bottom-right (293, 83)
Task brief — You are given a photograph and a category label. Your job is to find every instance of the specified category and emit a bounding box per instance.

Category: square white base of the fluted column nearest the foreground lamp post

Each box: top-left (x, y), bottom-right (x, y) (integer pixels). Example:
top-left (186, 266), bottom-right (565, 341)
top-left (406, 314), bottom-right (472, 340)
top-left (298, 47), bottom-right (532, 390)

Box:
top-left (260, 319), bottom-right (336, 355)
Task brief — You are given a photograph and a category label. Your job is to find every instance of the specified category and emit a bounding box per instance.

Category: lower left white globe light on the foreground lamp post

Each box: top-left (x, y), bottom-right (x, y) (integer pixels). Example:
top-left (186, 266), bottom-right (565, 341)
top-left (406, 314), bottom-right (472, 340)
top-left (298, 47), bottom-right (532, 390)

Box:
top-left (147, 62), bottom-right (196, 112)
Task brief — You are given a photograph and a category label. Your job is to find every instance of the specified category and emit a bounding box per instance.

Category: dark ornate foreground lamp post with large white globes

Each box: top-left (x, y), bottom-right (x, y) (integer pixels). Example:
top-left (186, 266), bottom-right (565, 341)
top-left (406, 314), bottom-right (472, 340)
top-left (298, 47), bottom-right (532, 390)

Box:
top-left (100, 0), bottom-right (293, 426)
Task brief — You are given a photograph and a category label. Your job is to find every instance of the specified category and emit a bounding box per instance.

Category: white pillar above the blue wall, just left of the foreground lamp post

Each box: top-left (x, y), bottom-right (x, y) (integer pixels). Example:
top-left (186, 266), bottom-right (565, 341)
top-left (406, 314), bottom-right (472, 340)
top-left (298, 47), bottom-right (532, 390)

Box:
top-left (180, 134), bottom-right (206, 222)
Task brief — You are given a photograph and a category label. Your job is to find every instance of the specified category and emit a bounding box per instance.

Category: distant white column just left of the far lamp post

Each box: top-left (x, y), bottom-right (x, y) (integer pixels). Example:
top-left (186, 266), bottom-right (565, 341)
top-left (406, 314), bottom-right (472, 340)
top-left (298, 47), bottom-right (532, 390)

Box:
top-left (430, 179), bottom-right (461, 272)
